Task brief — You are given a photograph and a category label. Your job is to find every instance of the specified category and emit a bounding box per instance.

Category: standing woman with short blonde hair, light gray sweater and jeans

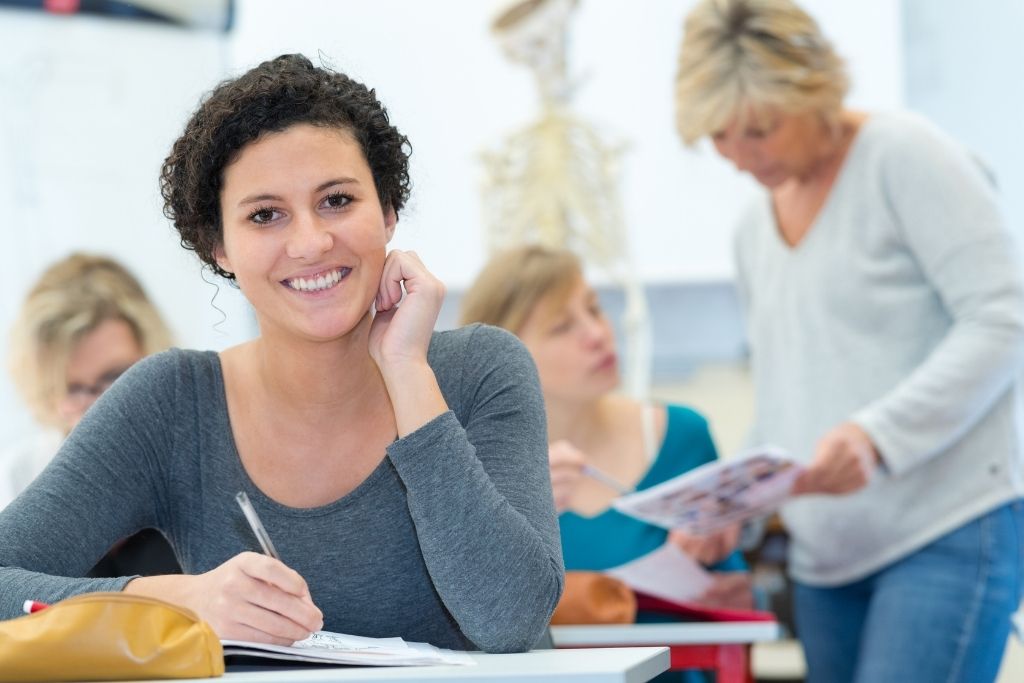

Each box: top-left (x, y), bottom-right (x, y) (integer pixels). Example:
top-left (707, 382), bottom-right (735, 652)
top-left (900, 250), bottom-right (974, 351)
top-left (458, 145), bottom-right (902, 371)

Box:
top-left (676, 0), bottom-right (1024, 683)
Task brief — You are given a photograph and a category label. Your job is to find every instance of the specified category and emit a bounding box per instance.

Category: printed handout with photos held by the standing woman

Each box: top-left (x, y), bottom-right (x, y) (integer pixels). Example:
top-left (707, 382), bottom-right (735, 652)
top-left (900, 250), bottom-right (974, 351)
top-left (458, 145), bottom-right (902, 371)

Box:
top-left (613, 446), bottom-right (803, 533)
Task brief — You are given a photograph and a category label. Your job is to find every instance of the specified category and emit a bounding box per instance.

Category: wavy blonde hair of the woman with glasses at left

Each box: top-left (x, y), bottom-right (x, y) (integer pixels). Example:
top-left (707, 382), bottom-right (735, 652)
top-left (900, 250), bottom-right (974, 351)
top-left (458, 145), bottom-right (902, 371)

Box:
top-left (8, 253), bottom-right (171, 428)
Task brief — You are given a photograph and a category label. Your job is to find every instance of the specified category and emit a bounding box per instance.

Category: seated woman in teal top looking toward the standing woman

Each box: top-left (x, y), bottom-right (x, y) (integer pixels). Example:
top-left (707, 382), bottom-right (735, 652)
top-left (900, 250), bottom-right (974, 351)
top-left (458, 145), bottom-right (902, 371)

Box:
top-left (462, 247), bottom-right (753, 608)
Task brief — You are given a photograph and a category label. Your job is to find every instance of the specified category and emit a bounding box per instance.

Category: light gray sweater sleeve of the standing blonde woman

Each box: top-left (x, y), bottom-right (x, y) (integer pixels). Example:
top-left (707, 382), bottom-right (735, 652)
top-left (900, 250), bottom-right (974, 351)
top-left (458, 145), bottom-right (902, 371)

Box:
top-left (853, 122), bottom-right (1024, 473)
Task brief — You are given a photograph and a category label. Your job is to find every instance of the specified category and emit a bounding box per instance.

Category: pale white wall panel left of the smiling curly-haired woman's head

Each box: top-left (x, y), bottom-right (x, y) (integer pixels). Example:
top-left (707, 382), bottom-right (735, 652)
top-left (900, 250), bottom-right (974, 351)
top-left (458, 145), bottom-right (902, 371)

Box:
top-left (0, 9), bottom-right (249, 445)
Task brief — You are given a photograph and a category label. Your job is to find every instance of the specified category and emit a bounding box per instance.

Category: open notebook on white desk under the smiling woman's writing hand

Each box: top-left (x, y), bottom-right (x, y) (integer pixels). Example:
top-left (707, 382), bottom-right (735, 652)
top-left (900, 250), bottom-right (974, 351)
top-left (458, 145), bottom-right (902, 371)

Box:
top-left (221, 631), bottom-right (473, 667)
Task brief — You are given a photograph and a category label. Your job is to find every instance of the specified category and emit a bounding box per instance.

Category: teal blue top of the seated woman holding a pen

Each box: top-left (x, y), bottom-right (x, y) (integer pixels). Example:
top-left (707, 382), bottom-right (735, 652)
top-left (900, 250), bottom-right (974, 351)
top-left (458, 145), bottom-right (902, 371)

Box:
top-left (558, 404), bottom-right (746, 571)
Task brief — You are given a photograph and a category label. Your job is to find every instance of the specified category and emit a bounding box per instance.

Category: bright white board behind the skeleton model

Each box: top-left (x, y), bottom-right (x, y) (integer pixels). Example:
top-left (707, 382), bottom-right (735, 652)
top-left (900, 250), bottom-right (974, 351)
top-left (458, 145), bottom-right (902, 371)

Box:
top-left (232, 0), bottom-right (902, 287)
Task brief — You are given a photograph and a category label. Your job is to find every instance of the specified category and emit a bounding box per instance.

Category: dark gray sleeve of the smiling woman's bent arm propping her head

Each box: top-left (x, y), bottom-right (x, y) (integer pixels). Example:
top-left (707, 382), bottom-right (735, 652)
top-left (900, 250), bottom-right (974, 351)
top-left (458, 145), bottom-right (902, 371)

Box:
top-left (388, 326), bottom-right (564, 652)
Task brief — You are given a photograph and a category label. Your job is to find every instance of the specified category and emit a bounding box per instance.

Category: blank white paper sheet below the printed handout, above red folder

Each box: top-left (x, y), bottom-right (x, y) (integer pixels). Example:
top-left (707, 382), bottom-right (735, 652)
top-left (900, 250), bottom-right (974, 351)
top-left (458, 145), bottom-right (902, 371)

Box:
top-left (605, 543), bottom-right (713, 602)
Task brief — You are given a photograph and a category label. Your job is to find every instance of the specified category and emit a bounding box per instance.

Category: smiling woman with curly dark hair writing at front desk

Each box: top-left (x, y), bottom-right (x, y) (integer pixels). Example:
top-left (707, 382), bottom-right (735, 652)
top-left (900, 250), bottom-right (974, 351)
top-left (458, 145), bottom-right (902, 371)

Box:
top-left (0, 54), bottom-right (563, 651)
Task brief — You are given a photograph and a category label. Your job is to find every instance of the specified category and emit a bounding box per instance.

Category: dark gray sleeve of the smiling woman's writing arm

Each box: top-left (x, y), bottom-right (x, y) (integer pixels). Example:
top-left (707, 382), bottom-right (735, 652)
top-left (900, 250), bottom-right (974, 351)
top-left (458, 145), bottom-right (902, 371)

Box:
top-left (0, 354), bottom-right (173, 618)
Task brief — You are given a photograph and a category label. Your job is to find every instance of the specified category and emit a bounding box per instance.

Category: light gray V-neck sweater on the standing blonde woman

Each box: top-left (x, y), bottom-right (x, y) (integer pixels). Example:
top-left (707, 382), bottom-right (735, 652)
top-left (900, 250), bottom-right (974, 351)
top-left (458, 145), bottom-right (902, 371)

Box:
top-left (736, 109), bottom-right (1024, 585)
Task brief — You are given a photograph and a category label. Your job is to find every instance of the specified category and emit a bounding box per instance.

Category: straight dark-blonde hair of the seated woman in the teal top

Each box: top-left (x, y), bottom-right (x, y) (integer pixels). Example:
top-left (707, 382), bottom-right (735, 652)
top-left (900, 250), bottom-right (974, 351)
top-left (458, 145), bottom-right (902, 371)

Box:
top-left (461, 246), bottom-right (583, 335)
